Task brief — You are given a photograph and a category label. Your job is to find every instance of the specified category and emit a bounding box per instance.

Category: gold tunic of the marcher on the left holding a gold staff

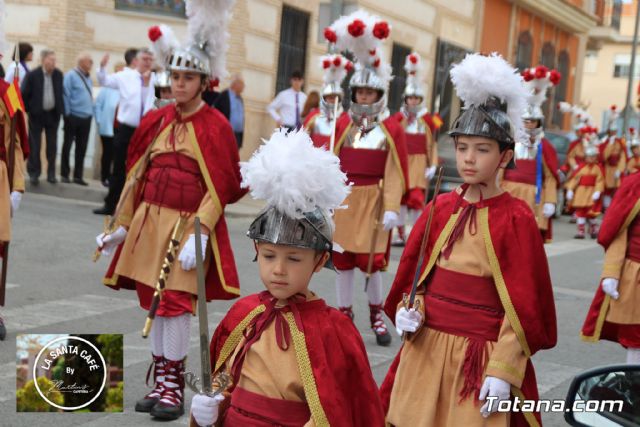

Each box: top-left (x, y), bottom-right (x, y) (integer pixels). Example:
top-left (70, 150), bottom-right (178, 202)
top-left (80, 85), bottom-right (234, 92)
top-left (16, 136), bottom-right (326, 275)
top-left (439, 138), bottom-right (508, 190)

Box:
top-left (116, 118), bottom-right (222, 295)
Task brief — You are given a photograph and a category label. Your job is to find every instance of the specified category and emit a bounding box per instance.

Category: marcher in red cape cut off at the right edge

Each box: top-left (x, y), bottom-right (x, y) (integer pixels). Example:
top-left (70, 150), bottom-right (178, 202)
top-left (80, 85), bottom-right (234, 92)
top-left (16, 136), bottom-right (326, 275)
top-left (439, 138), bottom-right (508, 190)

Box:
top-left (581, 174), bottom-right (640, 364)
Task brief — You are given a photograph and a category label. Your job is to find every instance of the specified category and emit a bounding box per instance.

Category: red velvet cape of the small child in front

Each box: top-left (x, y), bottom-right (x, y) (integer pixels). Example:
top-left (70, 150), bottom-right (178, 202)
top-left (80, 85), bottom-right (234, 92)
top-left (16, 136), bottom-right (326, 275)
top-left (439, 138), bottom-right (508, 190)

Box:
top-left (210, 294), bottom-right (384, 427)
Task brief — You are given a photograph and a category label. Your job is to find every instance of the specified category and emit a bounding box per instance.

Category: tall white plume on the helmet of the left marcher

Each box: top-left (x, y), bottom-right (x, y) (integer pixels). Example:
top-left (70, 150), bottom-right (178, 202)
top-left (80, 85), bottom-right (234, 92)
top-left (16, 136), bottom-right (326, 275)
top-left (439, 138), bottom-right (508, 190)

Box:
top-left (186, 0), bottom-right (235, 80)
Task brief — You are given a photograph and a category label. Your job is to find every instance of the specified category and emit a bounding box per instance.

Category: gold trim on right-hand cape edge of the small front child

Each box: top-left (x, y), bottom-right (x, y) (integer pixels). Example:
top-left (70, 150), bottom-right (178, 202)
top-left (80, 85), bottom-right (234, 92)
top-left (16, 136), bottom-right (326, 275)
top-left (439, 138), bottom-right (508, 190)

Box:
top-left (284, 312), bottom-right (330, 427)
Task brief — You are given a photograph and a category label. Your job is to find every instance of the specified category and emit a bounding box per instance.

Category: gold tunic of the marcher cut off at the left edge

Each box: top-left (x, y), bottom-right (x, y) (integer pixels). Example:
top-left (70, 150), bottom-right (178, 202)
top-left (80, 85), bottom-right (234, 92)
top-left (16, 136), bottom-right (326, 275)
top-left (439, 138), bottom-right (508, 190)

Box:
top-left (0, 100), bottom-right (24, 242)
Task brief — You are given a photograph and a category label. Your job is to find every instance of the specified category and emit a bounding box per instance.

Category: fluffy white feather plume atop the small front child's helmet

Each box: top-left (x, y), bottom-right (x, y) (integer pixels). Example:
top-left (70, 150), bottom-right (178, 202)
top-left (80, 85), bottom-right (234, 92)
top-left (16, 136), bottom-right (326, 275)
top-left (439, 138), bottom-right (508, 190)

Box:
top-left (240, 129), bottom-right (351, 218)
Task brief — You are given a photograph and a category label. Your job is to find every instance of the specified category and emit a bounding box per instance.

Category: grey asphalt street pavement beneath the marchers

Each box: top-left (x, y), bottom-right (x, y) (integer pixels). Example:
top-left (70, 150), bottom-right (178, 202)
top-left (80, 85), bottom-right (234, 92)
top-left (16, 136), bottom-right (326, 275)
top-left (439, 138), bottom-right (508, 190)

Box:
top-left (0, 191), bottom-right (625, 427)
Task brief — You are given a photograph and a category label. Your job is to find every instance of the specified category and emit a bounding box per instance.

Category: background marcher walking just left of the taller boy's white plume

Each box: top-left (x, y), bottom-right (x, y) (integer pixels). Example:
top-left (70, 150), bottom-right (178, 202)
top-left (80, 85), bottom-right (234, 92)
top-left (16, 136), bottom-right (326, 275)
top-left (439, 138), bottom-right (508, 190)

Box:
top-left (393, 52), bottom-right (442, 246)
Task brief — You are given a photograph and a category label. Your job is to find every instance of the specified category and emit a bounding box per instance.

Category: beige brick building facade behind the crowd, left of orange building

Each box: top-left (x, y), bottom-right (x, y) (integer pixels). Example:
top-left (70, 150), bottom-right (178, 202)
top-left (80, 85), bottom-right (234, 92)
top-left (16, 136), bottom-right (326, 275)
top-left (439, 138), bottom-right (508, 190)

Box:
top-left (3, 0), bottom-right (482, 176)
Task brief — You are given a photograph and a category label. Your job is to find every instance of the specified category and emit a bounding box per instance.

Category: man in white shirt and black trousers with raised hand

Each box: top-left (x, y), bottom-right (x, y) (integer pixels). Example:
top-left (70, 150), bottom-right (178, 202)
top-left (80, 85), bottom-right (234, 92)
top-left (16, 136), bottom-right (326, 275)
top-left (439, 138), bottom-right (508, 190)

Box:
top-left (93, 48), bottom-right (155, 215)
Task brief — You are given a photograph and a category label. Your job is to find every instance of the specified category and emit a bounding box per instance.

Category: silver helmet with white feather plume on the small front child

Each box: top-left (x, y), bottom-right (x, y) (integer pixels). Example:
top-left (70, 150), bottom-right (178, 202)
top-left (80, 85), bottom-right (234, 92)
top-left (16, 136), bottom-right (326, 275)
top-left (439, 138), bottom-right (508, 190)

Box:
top-left (240, 129), bottom-right (350, 266)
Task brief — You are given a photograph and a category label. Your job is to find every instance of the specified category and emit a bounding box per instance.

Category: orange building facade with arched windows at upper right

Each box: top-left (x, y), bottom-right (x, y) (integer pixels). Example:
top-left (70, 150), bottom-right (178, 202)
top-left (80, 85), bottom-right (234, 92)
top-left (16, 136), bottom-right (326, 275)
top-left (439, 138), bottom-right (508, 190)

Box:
top-left (480, 0), bottom-right (598, 129)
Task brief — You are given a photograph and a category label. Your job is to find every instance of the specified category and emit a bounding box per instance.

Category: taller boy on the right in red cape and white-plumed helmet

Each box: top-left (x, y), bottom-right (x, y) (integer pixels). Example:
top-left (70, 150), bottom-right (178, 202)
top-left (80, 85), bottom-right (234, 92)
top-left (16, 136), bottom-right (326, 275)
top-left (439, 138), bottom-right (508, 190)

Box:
top-left (381, 54), bottom-right (556, 427)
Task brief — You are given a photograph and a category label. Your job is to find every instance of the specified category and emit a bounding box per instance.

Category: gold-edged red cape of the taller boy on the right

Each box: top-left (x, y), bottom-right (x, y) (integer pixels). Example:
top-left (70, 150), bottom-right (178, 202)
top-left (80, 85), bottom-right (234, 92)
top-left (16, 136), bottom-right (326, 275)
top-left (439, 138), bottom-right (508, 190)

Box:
top-left (381, 191), bottom-right (557, 426)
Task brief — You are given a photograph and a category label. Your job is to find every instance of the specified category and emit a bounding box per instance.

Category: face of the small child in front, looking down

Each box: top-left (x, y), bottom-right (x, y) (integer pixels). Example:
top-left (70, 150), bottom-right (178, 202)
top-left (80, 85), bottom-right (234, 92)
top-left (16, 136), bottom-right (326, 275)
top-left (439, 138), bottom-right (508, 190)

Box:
top-left (257, 243), bottom-right (329, 300)
